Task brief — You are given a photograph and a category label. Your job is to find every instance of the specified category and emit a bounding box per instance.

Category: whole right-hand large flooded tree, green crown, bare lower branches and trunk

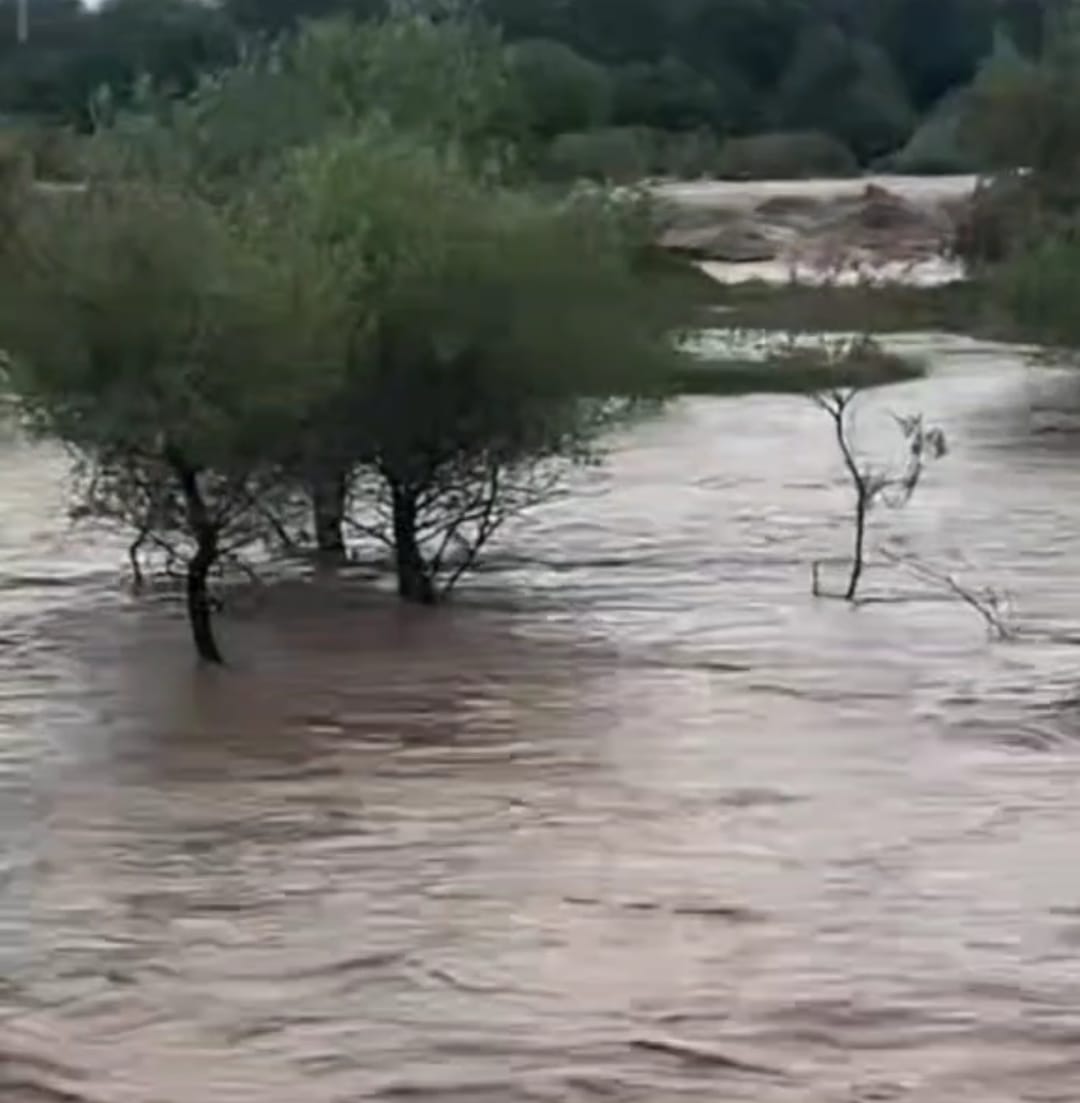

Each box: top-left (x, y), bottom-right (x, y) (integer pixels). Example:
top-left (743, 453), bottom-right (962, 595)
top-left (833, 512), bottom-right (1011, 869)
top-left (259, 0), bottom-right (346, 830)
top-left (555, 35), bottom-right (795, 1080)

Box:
top-left (286, 129), bottom-right (675, 604)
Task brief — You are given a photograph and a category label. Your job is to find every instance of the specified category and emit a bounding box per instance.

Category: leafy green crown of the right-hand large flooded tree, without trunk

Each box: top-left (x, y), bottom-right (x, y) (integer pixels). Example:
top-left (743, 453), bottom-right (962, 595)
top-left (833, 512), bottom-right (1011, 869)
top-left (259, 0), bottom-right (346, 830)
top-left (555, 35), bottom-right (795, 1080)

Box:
top-left (291, 124), bottom-right (666, 405)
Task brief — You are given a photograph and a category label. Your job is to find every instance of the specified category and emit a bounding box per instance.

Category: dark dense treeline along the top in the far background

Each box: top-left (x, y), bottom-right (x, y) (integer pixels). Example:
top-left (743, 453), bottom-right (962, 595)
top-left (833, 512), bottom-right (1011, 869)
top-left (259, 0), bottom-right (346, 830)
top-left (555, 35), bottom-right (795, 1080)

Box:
top-left (0, 0), bottom-right (1055, 169)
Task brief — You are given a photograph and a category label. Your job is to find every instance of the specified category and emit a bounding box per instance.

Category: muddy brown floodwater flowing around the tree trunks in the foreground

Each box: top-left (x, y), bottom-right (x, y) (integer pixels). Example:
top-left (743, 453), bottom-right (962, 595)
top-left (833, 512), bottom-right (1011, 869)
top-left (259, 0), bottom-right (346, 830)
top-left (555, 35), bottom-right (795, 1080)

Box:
top-left (0, 338), bottom-right (1080, 1103)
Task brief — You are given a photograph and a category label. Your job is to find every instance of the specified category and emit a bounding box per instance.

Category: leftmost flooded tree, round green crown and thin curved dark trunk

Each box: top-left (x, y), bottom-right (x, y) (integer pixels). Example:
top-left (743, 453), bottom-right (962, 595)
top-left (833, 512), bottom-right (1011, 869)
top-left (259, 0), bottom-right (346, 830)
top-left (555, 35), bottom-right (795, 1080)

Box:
top-left (0, 181), bottom-right (340, 663)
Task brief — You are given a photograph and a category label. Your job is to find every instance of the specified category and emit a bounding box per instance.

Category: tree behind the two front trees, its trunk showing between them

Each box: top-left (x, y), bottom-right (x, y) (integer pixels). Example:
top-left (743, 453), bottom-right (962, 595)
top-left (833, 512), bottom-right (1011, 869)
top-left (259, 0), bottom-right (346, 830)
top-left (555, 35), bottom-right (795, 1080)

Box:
top-left (93, 9), bottom-right (521, 561)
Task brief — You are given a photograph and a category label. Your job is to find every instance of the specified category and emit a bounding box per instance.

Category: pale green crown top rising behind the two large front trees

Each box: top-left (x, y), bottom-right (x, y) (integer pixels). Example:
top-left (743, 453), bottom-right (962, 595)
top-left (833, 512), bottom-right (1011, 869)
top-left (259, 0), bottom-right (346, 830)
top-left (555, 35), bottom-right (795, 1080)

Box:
top-left (83, 9), bottom-right (515, 196)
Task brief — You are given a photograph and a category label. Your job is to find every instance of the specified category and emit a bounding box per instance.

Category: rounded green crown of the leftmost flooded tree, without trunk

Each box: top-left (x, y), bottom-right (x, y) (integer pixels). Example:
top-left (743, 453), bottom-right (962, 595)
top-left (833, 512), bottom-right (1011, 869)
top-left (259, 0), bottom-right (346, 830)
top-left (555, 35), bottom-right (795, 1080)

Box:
top-left (2, 183), bottom-right (338, 469)
